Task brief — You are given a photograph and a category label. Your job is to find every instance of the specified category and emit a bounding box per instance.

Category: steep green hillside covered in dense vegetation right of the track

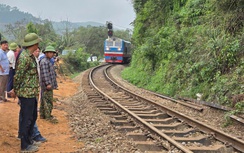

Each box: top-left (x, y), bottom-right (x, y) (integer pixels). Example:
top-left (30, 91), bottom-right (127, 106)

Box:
top-left (123, 0), bottom-right (244, 108)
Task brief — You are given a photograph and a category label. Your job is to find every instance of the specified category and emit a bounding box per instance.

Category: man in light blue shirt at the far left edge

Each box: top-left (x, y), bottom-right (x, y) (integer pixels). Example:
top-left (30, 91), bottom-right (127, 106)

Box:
top-left (0, 40), bottom-right (9, 102)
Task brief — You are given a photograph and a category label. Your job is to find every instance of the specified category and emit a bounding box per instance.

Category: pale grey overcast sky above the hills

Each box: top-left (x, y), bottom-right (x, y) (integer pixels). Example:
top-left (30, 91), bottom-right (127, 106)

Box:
top-left (0, 0), bottom-right (135, 29)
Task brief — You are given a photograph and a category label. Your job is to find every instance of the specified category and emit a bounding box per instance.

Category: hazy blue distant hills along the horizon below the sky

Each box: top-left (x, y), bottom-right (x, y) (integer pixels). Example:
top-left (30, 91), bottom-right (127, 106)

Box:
top-left (0, 4), bottom-right (104, 32)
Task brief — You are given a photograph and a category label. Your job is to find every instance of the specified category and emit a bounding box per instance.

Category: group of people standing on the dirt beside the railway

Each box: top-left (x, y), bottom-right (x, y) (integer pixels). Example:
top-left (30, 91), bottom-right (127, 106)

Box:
top-left (0, 33), bottom-right (57, 152)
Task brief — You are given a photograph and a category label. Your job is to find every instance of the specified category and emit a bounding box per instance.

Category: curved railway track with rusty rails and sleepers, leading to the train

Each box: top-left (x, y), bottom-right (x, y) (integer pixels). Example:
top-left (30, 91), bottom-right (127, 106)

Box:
top-left (82, 65), bottom-right (244, 153)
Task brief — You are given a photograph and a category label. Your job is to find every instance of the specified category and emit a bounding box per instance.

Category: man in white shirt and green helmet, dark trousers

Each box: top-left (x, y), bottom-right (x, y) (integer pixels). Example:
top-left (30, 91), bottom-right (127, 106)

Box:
top-left (7, 42), bottom-right (20, 92)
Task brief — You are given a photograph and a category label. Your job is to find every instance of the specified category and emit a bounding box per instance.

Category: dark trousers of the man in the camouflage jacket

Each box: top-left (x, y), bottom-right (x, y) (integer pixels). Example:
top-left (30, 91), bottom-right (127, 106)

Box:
top-left (19, 97), bottom-right (37, 149)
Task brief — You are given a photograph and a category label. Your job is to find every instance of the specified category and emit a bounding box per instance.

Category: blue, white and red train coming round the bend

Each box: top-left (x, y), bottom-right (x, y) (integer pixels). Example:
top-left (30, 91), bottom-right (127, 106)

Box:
top-left (104, 37), bottom-right (131, 64)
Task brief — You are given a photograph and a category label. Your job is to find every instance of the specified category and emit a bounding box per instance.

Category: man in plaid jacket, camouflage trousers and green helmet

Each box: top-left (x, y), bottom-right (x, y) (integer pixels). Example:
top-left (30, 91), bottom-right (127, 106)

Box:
top-left (40, 46), bottom-right (57, 123)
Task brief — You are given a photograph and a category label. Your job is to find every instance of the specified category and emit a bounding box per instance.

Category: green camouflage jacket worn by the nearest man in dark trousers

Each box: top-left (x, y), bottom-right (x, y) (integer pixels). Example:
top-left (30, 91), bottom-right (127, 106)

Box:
top-left (14, 50), bottom-right (39, 98)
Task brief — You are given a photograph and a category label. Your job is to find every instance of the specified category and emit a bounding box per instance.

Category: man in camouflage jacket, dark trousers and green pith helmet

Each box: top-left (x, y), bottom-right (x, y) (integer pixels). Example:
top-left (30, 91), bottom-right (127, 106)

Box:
top-left (14, 33), bottom-right (42, 152)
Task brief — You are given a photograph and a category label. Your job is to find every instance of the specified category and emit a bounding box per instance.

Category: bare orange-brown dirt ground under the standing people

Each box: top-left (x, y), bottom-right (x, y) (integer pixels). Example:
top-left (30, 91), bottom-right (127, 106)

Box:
top-left (0, 78), bottom-right (83, 153)
